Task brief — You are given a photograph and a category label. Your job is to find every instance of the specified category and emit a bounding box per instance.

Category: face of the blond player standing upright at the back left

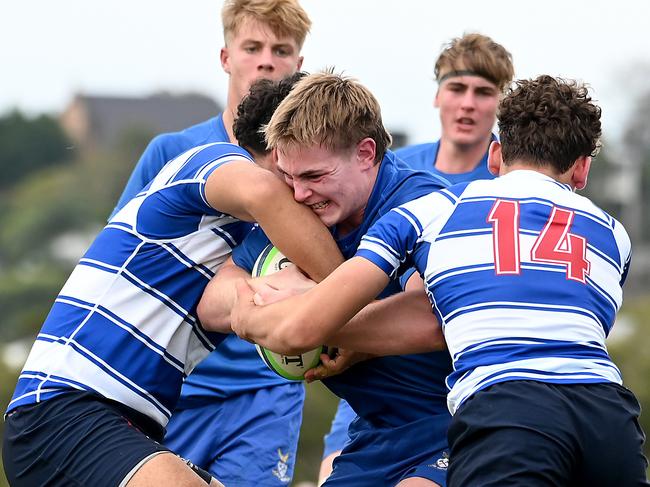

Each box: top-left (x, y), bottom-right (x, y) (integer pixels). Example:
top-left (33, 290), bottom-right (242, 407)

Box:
top-left (221, 19), bottom-right (302, 104)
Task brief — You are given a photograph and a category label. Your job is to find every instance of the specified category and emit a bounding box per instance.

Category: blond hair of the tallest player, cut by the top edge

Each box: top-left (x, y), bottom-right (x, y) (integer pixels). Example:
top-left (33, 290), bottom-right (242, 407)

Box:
top-left (221, 0), bottom-right (311, 49)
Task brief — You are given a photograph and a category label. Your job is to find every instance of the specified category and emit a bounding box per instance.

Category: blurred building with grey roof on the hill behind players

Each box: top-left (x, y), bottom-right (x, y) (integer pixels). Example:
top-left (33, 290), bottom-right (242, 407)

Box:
top-left (60, 93), bottom-right (222, 150)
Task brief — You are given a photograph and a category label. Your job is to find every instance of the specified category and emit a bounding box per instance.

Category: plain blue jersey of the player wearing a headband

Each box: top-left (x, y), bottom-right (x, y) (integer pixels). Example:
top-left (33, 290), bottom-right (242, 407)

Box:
top-left (395, 135), bottom-right (496, 184)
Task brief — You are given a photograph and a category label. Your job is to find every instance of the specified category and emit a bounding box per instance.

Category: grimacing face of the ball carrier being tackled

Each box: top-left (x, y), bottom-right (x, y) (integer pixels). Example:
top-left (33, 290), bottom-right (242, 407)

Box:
top-left (277, 145), bottom-right (374, 232)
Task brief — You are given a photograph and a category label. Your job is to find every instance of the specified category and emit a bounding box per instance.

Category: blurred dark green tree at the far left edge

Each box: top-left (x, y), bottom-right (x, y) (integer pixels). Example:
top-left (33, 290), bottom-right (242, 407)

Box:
top-left (0, 111), bottom-right (70, 190)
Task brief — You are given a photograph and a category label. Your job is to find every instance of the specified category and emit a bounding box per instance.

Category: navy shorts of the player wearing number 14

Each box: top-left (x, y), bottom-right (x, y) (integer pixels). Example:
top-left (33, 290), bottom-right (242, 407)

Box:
top-left (447, 380), bottom-right (648, 487)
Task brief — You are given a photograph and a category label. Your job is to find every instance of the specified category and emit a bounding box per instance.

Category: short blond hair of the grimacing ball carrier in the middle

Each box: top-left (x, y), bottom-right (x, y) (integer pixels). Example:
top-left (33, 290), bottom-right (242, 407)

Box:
top-left (265, 70), bottom-right (391, 162)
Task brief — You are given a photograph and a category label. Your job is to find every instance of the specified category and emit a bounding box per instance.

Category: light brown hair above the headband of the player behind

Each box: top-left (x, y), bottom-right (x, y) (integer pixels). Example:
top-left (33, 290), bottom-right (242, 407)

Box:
top-left (434, 33), bottom-right (515, 91)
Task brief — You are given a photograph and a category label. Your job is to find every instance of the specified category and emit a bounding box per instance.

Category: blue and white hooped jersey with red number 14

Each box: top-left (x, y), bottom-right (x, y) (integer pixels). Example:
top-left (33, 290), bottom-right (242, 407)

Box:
top-left (357, 170), bottom-right (631, 413)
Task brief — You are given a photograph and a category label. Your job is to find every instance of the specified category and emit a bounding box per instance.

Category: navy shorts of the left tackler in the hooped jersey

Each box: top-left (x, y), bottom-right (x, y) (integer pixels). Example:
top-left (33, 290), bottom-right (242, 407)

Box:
top-left (2, 391), bottom-right (169, 487)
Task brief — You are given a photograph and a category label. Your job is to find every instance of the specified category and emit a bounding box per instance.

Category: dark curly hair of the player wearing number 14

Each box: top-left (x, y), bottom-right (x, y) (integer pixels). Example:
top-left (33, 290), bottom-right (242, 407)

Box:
top-left (497, 75), bottom-right (601, 174)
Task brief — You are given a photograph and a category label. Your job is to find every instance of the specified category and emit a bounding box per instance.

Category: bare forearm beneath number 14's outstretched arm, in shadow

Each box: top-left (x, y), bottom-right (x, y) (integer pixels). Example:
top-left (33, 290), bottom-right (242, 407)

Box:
top-left (327, 290), bottom-right (446, 355)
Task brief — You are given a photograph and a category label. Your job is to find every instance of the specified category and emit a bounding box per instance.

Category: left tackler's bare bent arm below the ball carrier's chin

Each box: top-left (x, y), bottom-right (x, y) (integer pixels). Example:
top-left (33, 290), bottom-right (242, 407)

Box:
top-left (205, 162), bottom-right (343, 282)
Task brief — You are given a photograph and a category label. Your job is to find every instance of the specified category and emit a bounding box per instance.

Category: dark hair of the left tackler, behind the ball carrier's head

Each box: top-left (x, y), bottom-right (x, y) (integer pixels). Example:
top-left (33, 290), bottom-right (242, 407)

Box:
top-left (233, 72), bottom-right (307, 155)
